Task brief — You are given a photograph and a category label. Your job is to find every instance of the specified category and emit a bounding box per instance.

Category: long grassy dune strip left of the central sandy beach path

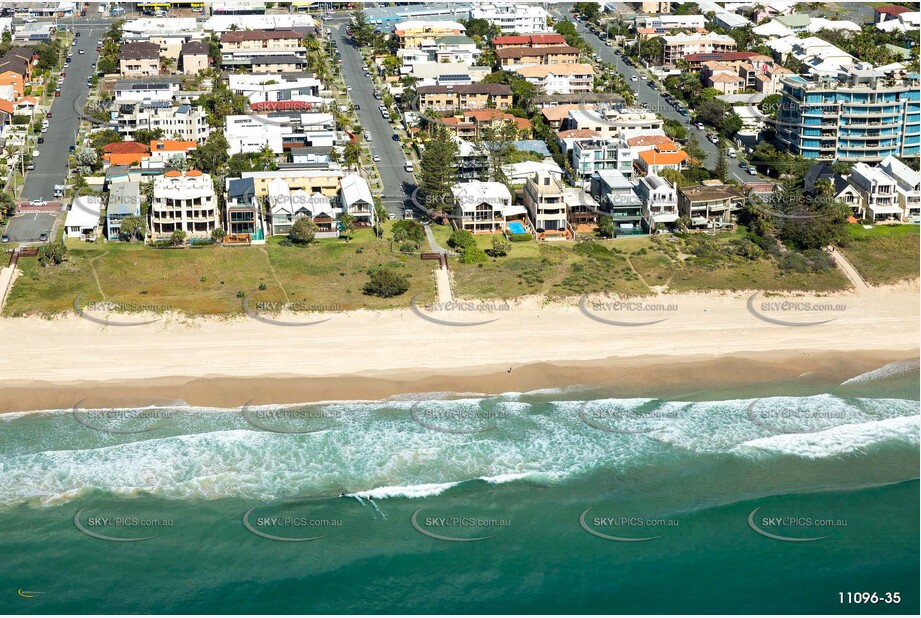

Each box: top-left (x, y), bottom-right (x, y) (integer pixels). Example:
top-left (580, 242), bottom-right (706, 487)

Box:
top-left (4, 223), bottom-right (435, 315)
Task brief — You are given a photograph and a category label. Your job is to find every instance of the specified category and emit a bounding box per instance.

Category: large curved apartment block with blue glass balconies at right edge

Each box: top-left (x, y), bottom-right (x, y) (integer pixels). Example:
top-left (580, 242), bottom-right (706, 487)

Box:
top-left (777, 64), bottom-right (921, 162)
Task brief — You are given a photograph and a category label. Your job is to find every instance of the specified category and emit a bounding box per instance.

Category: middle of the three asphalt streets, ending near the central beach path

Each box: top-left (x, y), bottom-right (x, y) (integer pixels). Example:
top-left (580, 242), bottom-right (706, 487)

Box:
top-left (325, 21), bottom-right (416, 219)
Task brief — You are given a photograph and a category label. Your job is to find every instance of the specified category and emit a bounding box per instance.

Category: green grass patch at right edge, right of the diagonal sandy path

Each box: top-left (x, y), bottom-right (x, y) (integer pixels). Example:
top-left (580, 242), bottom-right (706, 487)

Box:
top-left (841, 224), bottom-right (919, 285)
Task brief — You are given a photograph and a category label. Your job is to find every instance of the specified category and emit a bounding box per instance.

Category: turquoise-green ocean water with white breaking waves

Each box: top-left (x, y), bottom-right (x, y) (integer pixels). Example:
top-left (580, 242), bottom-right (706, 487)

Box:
top-left (0, 362), bottom-right (919, 614)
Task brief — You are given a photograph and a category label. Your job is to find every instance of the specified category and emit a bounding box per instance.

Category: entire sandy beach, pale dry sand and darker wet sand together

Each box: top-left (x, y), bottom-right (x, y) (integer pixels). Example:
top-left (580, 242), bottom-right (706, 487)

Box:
top-left (0, 283), bottom-right (921, 411)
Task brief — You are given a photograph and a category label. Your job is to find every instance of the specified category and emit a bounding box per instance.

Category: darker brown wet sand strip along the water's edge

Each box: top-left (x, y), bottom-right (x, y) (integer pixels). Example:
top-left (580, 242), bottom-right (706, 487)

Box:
top-left (0, 349), bottom-right (919, 414)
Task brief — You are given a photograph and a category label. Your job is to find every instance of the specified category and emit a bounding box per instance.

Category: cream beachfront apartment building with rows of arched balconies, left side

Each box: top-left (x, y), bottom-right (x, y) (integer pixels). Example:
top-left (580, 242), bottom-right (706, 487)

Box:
top-left (150, 170), bottom-right (220, 239)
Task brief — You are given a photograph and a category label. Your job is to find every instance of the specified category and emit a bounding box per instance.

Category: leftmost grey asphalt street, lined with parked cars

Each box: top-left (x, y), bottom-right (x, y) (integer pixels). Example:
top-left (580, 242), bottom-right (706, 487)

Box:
top-left (21, 21), bottom-right (107, 201)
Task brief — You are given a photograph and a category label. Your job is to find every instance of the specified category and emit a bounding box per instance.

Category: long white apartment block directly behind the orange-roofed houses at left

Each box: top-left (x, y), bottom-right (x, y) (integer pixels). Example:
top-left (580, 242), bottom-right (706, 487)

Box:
top-left (117, 102), bottom-right (211, 143)
